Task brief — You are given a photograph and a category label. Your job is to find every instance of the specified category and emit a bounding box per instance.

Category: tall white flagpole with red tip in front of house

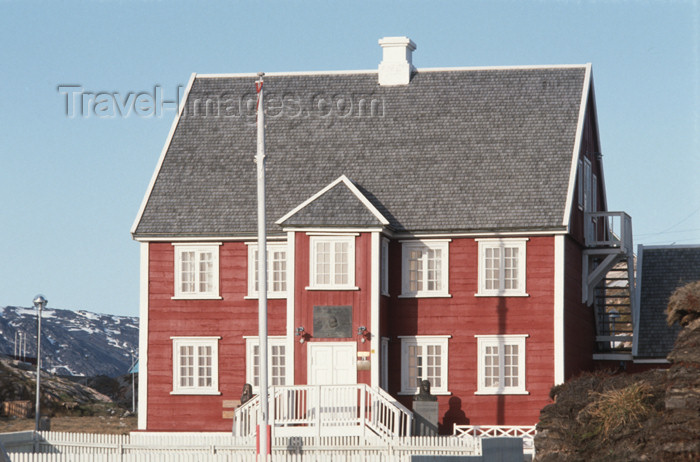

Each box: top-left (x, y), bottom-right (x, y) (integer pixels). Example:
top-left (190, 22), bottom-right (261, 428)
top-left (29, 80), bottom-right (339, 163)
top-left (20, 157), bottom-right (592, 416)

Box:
top-left (255, 72), bottom-right (270, 461)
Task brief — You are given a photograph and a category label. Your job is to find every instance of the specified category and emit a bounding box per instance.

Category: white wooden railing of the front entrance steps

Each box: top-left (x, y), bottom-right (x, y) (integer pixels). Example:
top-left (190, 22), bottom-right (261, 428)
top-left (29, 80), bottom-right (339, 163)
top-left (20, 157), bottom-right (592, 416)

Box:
top-left (233, 384), bottom-right (413, 440)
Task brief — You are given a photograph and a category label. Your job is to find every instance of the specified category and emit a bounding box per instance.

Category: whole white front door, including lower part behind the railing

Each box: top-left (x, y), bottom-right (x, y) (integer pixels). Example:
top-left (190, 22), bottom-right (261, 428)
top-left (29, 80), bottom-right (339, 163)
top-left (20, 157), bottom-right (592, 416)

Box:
top-left (308, 342), bottom-right (358, 435)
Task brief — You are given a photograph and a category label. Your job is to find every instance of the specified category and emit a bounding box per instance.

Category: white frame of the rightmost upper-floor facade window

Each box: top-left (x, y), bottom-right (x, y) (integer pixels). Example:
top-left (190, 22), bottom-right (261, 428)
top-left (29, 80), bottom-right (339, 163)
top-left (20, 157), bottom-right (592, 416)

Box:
top-left (476, 238), bottom-right (529, 297)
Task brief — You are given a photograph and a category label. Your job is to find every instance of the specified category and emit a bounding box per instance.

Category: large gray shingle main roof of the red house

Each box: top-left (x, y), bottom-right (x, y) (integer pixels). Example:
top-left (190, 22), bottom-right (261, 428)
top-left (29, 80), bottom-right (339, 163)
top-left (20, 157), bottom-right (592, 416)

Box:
top-left (134, 66), bottom-right (587, 238)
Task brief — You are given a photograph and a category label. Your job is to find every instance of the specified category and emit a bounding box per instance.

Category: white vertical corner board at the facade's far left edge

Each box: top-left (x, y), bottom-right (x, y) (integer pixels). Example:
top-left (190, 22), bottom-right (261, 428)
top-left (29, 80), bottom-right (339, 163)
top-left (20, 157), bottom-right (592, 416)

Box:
top-left (138, 242), bottom-right (149, 430)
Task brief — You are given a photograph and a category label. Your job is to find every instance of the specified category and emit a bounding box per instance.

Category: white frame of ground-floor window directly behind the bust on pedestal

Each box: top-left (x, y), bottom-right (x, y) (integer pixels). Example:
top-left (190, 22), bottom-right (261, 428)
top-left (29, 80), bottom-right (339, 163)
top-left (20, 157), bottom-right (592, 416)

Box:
top-left (399, 335), bottom-right (452, 395)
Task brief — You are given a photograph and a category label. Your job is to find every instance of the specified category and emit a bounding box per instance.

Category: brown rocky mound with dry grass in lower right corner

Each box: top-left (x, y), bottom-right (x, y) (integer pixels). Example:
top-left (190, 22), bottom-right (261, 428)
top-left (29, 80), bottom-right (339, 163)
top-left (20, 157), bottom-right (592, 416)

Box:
top-left (535, 319), bottom-right (700, 462)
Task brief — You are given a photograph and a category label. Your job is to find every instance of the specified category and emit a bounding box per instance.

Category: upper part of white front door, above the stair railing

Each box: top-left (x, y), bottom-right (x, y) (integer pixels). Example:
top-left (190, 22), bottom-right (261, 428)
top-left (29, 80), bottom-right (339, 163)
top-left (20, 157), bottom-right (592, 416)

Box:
top-left (307, 342), bottom-right (357, 385)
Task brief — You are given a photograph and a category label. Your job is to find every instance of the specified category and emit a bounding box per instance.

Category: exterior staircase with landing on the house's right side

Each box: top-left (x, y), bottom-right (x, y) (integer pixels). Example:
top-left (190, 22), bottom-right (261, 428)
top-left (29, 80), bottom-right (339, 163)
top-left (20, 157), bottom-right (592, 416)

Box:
top-left (583, 212), bottom-right (636, 355)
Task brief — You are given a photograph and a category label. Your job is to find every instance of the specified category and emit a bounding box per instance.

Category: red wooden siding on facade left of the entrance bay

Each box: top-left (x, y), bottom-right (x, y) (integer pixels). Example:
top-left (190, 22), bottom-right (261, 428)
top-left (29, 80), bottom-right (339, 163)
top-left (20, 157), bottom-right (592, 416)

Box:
top-left (147, 242), bottom-right (286, 431)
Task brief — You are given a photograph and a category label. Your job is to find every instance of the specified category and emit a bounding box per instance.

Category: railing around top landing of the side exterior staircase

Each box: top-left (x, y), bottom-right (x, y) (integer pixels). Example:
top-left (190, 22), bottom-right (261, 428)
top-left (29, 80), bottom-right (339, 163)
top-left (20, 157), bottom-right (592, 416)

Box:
top-left (585, 212), bottom-right (634, 252)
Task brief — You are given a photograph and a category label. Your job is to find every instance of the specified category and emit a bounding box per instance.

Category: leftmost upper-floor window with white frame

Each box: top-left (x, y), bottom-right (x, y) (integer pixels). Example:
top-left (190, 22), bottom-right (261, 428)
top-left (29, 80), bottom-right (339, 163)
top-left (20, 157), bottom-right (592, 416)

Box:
top-left (173, 244), bottom-right (220, 299)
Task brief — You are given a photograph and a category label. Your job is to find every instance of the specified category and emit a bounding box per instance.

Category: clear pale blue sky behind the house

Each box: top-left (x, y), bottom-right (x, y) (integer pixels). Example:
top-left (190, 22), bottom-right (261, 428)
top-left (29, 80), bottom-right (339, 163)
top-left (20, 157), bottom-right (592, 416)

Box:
top-left (0, 0), bottom-right (700, 315)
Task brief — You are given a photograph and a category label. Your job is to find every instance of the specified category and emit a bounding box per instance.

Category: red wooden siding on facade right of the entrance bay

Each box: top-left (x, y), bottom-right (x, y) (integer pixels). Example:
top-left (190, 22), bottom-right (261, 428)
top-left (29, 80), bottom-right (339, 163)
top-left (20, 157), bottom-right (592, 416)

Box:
top-left (387, 237), bottom-right (554, 433)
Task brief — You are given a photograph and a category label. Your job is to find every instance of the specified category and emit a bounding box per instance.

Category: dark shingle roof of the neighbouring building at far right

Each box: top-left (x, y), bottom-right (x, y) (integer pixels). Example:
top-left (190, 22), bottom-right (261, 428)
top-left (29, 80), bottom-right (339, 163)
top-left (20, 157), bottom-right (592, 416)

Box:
top-left (637, 246), bottom-right (700, 358)
